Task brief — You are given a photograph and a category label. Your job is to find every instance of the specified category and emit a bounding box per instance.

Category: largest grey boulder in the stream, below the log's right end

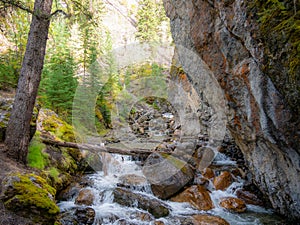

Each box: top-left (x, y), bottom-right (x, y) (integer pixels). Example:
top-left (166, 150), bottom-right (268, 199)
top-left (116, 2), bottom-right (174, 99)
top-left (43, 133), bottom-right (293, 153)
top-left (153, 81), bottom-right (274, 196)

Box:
top-left (143, 153), bottom-right (194, 199)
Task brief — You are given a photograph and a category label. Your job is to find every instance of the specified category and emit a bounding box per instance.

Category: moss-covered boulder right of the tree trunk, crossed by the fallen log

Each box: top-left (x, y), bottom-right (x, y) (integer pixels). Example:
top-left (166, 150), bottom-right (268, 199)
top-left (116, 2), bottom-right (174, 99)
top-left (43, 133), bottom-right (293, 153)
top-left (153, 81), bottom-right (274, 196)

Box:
top-left (28, 109), bottom-right (87, 192)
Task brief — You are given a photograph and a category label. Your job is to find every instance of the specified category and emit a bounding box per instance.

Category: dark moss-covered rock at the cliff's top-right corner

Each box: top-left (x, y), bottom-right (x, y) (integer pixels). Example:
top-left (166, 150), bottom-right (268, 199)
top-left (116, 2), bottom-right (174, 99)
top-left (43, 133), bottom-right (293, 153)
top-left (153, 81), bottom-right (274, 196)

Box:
top-left (247, 0), bottom-right (300, 116)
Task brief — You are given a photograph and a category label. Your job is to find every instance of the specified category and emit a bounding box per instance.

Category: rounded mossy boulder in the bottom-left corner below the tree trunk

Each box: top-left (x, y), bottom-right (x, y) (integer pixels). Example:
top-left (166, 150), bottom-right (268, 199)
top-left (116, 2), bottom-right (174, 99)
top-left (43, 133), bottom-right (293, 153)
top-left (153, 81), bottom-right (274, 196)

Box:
top-left (0, 173), bottom-right (59, 224)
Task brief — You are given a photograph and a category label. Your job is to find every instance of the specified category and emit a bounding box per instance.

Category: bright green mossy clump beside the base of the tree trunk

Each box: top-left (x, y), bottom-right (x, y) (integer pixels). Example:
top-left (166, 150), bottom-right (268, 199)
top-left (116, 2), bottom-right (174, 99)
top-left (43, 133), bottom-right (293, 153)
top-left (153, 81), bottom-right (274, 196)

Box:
top-left (27, 133), bottom-right (48, 169)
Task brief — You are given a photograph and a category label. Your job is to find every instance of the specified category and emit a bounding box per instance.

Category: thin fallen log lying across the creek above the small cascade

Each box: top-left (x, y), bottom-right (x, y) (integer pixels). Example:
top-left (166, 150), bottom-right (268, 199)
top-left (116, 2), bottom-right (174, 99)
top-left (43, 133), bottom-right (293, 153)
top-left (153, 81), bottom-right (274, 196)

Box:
top-left (41, 138), bottom-right (171, 155)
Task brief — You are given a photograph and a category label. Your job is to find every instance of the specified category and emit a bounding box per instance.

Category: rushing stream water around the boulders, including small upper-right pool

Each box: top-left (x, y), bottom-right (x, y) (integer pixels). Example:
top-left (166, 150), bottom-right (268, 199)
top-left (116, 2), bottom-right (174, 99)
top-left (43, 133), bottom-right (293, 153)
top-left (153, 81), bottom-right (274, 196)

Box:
top-left (59, 150), bottom-right (283, 225)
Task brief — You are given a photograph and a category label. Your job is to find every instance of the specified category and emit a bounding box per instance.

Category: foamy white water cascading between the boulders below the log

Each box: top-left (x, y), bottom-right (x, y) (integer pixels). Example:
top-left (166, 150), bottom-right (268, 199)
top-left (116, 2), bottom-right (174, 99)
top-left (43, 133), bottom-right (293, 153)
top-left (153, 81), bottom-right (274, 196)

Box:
top-left (58, 152), bottom-right (284, 225)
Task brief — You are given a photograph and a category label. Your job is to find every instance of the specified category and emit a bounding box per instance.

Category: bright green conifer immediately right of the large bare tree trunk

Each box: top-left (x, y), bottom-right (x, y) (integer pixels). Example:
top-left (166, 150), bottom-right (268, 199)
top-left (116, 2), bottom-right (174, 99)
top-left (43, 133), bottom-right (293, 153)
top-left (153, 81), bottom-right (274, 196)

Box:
top-left (39, 19), bottom-right (77, 119)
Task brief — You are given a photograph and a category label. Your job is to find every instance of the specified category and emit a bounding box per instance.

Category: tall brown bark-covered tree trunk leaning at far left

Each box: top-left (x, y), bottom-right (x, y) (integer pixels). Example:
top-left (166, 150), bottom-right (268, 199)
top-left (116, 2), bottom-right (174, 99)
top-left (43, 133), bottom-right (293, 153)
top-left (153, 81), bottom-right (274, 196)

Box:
top-left (5, 0), bottom-right (52, 164)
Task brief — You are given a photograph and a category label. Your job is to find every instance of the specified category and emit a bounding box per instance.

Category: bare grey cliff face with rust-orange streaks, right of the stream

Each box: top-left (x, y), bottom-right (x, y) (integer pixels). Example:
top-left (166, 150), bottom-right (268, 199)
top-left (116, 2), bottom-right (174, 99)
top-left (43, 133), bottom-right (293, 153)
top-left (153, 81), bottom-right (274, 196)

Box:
top-left (164, 0), bottom-right (300, 219)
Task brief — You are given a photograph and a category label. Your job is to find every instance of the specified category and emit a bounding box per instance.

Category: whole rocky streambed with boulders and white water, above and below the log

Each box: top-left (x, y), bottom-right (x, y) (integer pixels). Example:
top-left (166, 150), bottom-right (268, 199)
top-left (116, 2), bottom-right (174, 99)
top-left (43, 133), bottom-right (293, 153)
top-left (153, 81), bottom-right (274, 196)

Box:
top-left (58, 99), bottom-right (285, 225)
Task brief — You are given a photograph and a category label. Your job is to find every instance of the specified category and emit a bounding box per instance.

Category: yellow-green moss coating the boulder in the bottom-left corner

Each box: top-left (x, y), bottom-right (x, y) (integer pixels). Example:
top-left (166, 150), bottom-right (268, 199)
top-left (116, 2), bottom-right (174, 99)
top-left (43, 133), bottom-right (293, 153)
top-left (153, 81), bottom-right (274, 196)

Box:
top-left (5, 173), bottom-right (59, 217)
